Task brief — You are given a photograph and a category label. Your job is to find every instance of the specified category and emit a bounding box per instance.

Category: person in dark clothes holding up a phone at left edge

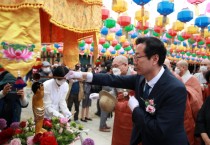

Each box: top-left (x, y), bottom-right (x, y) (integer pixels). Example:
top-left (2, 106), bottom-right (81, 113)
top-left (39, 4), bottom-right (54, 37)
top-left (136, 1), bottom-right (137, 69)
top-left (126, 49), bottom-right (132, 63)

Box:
top-left (0, 72), bottom-right (28, 126)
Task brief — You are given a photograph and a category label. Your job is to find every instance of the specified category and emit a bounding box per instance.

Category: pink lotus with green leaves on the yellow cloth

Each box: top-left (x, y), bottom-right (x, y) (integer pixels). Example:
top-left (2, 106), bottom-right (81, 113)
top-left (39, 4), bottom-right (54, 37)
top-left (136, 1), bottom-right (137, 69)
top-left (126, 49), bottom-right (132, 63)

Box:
top-left (2, 42), bottom-right (35, 61)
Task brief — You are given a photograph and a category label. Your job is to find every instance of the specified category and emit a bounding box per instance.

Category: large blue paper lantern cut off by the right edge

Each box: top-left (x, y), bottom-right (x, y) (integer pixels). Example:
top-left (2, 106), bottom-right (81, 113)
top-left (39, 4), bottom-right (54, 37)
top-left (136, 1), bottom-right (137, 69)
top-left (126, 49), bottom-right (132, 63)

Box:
top-left (195, 15), bottom-right (210, 28)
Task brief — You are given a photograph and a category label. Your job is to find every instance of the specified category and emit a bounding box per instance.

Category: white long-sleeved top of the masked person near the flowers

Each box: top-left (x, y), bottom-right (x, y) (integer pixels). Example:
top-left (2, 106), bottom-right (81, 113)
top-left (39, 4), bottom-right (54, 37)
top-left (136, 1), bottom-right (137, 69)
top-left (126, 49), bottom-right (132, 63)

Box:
top-left (44, 79), bottom-right (71, 118)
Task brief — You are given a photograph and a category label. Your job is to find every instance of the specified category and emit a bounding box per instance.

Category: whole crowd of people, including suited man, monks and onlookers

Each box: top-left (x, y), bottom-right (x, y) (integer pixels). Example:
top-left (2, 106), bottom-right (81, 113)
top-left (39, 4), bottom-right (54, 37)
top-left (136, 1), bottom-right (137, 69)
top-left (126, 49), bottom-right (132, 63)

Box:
top-left (0, 37), bottom-right (210, 145)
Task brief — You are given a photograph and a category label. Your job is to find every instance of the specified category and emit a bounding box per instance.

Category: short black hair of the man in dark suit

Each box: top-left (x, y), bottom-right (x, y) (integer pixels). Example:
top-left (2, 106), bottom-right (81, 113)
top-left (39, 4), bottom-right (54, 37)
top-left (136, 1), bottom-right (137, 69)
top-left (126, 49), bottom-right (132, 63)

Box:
top-left (136, 37), bottom-right (166, 66)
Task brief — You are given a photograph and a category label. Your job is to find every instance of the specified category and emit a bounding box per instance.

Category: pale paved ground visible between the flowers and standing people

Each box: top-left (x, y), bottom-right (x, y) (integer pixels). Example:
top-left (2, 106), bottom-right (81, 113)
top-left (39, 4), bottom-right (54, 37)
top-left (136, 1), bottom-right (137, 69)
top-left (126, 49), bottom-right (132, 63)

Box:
top-left (21, 88), bottom-right (114, 145)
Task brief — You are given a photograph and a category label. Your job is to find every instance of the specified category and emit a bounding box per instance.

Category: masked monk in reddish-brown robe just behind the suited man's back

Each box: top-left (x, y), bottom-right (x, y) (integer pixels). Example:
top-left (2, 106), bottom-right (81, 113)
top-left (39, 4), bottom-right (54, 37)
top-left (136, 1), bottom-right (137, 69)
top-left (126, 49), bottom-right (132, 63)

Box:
top-left (175, 60), bottom-right (203, 145)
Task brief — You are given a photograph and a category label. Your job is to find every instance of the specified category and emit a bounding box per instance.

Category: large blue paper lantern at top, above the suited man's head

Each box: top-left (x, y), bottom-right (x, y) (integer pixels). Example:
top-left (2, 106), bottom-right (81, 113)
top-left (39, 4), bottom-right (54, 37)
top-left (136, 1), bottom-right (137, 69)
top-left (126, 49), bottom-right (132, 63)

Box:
top-left (157, 0), bottom-right (174, 16)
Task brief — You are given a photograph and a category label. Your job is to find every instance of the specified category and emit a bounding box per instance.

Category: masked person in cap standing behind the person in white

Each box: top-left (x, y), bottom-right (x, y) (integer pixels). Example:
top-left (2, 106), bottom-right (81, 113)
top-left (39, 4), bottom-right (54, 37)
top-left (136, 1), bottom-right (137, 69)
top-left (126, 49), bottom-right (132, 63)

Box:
top-left (39, 61), bottom-right (52, 83)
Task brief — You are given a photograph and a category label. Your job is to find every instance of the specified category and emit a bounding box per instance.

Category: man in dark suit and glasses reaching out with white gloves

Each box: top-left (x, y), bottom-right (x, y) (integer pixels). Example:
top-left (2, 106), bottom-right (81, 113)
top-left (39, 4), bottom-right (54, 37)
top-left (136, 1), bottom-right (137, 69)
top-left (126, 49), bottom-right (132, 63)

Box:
top-left (66, 37), bottom-right (188, 145)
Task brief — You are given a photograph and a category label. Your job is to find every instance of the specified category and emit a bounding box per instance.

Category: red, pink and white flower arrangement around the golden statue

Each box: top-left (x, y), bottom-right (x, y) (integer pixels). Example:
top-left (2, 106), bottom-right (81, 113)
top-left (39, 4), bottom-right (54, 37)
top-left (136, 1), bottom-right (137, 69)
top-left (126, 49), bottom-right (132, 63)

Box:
top-left (0, 117), bottom-right (94, 145)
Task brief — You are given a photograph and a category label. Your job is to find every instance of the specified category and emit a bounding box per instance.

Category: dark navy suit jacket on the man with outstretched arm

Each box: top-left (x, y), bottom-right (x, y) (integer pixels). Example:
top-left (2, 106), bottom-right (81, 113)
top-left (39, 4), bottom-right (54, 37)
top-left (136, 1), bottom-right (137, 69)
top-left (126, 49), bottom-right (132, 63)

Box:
top-left (92, 67), bottom-right (188, 145)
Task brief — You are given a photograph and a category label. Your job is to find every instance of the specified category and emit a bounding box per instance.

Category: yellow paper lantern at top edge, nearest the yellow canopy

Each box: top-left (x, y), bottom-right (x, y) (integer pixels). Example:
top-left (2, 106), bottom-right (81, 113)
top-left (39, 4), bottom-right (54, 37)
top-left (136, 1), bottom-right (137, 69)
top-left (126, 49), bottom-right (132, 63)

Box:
top-left (112, 0), bottom-right (128, 13)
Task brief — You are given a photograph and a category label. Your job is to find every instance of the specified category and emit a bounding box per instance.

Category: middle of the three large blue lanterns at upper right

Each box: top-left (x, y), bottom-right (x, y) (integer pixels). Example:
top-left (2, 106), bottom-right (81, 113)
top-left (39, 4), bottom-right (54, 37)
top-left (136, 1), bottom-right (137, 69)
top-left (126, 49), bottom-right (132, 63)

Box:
top-left (177, 8), bottom-right (193, 23)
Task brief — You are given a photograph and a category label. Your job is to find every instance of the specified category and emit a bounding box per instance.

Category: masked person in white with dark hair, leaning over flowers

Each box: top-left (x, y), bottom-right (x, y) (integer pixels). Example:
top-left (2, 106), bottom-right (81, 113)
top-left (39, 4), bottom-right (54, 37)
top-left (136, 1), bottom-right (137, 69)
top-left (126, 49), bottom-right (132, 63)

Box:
top-left (43, 66), bottom-right (72, 119)
